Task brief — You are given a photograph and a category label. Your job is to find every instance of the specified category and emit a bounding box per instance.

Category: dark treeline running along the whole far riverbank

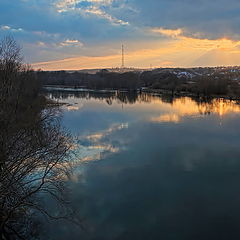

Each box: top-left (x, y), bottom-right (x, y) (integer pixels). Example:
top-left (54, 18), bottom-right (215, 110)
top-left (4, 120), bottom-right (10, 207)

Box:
top-left (36, 69), bottom-right (240, 96)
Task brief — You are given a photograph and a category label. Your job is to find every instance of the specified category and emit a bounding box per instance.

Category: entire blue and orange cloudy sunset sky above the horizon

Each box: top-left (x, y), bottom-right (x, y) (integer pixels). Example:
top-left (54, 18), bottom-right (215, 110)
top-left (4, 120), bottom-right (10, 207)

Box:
top-left (0, 0), bottom-right (240, 70)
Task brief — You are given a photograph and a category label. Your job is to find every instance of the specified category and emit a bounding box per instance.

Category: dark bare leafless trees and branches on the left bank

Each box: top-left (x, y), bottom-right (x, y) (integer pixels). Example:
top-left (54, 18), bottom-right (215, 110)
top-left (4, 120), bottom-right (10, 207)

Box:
top-left (0, 37), bottom-right (72, 239)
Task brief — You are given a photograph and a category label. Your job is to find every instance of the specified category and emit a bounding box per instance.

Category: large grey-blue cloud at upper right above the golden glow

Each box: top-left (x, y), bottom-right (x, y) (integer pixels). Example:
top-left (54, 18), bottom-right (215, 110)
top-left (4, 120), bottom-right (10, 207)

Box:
top-left (123, 0), bottom-right (240, 39)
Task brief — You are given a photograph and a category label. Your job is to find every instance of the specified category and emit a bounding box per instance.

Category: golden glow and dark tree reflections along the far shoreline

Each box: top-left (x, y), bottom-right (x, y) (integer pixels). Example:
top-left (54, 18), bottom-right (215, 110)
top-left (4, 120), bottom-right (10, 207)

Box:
top-left (48, 92), bottom-right (240, 118)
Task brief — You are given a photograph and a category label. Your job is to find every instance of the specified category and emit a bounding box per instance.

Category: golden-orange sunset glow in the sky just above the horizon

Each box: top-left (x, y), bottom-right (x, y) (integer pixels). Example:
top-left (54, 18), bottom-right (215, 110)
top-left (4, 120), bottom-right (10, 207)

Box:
top-left (32, 29), bottom-right (240, 70)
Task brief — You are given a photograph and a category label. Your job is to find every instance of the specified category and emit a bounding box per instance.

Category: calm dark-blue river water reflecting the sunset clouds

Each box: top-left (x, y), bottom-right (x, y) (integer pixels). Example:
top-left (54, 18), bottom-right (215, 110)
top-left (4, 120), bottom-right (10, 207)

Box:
top-left (44, 93), bottom-right (240, 240)
